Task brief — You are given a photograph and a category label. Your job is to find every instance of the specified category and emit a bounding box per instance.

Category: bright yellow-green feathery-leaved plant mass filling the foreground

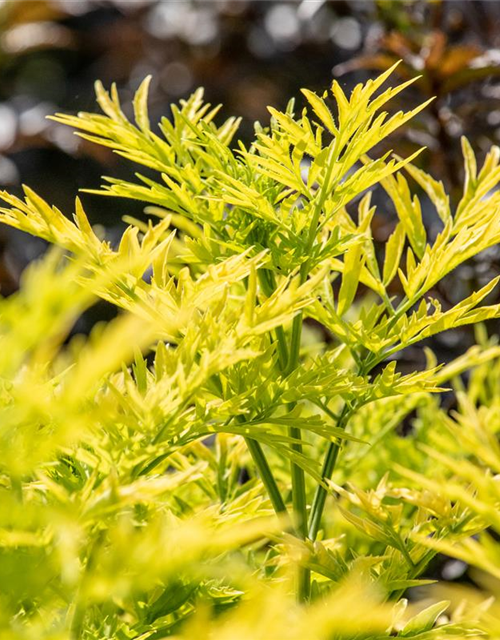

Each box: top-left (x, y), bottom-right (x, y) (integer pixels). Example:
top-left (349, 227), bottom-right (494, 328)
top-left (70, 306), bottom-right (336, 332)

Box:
top-left (0, 63), bottom-right (500, 640)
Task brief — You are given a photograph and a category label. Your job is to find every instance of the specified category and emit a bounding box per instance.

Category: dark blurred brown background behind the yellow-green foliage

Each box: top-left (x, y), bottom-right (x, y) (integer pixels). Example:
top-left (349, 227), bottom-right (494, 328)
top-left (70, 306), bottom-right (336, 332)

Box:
top-left (0, 0), bottom-right (500, 592)
